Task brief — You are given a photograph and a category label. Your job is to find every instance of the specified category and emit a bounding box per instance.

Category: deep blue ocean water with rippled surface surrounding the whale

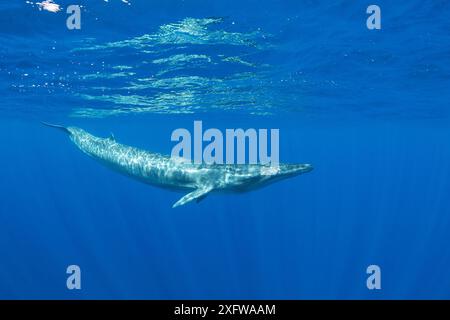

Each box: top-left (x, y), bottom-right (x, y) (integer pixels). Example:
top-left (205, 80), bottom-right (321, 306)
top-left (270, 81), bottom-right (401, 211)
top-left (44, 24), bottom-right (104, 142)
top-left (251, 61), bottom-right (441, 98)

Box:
top-left (0, 0), bottom-right (450, 299)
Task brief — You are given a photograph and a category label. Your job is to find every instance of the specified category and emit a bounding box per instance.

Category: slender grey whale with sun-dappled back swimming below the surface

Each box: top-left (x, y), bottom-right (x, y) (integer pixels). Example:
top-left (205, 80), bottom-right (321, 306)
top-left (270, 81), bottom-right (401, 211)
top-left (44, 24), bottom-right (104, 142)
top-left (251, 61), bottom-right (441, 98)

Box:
top-left (43, 122), bottom-right (313, 208)
